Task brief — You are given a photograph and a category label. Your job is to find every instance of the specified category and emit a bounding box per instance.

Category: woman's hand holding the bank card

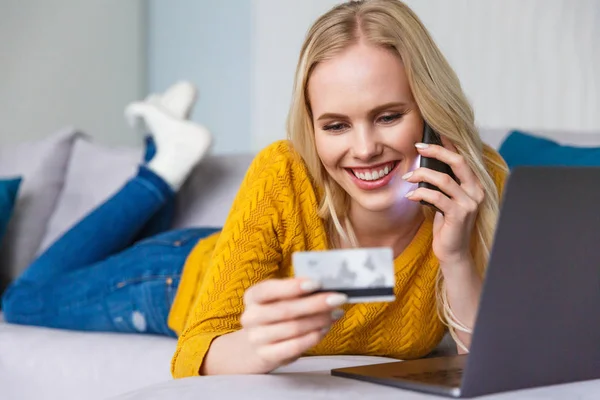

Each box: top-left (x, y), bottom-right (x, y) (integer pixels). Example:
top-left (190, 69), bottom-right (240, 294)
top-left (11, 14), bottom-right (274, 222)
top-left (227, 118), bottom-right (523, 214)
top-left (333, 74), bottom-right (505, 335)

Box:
top-left (241, 278), bottom-right (348, 373)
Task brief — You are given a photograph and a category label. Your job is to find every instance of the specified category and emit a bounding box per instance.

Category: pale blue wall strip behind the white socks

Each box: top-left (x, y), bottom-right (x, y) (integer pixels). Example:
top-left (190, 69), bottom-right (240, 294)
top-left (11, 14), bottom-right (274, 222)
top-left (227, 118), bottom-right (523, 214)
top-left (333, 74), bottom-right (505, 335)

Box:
top-left (148, 0), bottom-right (253, 153)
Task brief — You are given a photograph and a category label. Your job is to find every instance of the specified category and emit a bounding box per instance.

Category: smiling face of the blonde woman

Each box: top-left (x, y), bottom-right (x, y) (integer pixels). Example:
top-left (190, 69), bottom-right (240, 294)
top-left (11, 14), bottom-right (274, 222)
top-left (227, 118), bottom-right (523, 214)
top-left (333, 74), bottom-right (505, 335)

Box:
top-left (308, 43), bottom-right (423, 212)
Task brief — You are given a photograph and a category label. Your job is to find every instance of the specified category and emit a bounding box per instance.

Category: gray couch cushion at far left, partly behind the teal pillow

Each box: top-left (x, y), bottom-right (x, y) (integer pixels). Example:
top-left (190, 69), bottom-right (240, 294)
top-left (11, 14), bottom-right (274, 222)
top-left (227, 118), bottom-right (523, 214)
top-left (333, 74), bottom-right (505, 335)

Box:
top-left (0, 128), bottom-right (80, 290)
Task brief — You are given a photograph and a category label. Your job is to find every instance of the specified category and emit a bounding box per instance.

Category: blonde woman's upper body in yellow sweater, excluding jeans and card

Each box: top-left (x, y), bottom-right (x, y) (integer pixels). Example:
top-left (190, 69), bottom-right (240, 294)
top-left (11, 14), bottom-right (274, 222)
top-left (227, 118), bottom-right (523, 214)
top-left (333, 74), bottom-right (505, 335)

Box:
top-left (1, 0), bottom-right (506, 377)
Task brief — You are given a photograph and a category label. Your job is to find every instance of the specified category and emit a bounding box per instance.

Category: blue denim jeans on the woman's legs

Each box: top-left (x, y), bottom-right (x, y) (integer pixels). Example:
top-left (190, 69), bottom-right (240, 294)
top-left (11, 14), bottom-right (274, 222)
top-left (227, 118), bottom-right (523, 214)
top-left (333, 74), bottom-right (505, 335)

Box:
top-left (2, 140), bottom-right (219, 337)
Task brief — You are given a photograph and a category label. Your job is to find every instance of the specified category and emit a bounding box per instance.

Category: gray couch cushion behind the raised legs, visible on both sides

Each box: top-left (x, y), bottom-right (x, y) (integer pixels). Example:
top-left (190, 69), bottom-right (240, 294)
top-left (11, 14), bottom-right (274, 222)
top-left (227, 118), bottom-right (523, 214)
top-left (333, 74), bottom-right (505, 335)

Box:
top-left (41, 139), bottom-right (254, 250)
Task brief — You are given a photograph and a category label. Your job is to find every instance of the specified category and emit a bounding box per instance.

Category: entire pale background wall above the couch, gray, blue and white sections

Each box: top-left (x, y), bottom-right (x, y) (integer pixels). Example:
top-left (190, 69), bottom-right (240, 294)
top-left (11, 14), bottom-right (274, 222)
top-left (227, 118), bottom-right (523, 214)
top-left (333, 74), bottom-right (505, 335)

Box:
top-left (0, 0), bottom-right (600, 153)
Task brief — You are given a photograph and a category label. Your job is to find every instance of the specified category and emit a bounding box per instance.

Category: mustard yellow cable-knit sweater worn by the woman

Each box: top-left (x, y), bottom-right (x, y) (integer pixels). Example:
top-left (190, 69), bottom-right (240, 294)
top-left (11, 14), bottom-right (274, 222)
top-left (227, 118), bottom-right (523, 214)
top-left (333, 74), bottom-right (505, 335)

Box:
top-left (169, 141), bottom-right (505, 378)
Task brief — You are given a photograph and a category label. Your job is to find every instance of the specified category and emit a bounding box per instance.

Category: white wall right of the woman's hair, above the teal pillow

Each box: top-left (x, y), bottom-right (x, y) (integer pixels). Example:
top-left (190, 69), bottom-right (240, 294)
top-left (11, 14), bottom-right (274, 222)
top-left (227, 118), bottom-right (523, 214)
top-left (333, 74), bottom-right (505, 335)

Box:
top-left (400, 0), bottom-right (600, 131)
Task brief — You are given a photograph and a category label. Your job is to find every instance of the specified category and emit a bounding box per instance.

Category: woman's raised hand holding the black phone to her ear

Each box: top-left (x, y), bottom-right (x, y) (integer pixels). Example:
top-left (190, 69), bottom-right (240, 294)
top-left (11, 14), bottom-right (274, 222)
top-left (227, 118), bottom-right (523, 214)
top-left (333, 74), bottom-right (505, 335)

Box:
top-left (403, 139), bottom-right (484, 265)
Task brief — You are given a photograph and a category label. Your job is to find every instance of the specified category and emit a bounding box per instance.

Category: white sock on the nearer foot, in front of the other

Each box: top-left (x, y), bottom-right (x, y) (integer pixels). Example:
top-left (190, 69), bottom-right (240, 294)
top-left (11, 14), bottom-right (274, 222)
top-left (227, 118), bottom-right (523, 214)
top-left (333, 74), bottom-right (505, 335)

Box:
top-left (126, 102), bottom-right (212, 191)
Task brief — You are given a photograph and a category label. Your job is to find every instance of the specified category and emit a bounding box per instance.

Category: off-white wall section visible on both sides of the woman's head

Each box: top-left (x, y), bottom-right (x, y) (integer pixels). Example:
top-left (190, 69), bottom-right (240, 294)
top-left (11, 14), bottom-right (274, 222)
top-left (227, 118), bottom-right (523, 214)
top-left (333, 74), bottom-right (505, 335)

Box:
top-left (252, 0), bottom-right (600, 149)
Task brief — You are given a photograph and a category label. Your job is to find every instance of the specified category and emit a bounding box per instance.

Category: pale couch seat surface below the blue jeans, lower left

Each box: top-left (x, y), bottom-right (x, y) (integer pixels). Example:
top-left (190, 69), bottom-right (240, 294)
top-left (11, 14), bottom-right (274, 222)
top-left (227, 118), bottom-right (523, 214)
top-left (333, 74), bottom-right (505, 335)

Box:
top-left (0, 315), bottom-right (176, 400)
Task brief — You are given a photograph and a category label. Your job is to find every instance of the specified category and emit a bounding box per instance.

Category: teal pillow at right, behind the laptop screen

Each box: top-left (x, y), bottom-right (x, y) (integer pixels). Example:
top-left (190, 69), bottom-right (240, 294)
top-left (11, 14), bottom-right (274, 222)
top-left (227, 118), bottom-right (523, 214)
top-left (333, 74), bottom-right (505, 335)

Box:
top-left (498, 131), bottom-right (600, 169)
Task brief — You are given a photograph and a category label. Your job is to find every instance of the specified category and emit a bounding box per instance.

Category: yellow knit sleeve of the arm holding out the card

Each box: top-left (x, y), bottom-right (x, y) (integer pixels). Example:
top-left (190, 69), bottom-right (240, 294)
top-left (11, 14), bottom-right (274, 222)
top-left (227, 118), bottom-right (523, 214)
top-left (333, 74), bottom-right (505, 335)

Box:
top-left (171, 142), bottom-right (293, 378)
